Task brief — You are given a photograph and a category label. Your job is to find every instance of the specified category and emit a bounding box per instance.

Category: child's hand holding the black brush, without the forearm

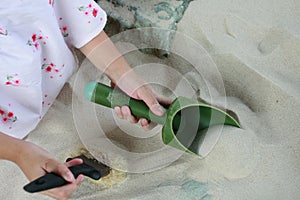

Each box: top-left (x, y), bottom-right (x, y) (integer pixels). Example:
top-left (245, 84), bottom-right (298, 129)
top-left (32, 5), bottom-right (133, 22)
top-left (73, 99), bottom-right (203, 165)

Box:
top-left (16, 142), bottom-right (84, 199)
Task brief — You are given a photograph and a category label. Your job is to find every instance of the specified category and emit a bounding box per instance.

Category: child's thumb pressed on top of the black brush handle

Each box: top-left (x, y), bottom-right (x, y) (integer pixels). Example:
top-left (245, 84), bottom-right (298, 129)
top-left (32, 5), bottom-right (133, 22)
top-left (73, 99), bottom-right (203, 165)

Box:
top-left (44, 159), bottom-right (75, 182)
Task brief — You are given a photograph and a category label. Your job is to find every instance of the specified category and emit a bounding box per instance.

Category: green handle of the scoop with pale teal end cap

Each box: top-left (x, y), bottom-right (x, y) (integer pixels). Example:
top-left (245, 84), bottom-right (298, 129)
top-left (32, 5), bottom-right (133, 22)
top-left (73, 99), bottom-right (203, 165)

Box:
top-left (84, 82), bottom-right (166, 124)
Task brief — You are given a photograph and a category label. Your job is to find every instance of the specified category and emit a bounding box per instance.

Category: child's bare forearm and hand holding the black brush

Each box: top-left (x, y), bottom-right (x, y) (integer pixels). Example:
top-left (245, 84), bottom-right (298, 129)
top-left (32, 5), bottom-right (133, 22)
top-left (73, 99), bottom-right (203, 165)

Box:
top-left (0, 133), bottom-right (83, 199)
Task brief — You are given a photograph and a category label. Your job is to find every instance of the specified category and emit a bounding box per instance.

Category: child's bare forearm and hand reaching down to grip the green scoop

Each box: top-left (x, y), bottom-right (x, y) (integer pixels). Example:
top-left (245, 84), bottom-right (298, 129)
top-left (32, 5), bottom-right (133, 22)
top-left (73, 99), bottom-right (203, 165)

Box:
top-left (80, 31), bottom-right (171, 129)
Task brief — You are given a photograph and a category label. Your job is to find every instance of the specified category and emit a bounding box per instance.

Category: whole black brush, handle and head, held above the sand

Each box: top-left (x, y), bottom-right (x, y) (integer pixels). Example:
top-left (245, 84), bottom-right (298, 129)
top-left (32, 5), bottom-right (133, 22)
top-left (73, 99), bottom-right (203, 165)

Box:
top-left (24, 155), bottom-right (110, 193)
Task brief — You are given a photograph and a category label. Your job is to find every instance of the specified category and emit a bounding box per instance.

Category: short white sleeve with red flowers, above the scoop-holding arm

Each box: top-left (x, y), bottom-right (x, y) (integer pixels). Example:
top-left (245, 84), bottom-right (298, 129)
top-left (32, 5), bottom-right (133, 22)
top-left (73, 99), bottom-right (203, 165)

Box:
top-left (53, 0), bottom-right (107, 48)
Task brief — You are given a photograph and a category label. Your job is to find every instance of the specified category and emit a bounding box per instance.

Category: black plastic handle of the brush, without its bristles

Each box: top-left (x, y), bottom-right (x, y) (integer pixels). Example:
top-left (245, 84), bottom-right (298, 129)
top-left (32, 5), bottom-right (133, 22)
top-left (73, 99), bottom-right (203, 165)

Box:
top-left (24, 163), bottom-right (101, 193)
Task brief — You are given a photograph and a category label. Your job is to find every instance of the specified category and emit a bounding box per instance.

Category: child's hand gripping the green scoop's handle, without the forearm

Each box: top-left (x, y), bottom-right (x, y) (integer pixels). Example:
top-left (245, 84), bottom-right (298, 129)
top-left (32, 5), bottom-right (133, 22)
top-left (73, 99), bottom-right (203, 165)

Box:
top-left (111, 73), bottom-right (172, 130)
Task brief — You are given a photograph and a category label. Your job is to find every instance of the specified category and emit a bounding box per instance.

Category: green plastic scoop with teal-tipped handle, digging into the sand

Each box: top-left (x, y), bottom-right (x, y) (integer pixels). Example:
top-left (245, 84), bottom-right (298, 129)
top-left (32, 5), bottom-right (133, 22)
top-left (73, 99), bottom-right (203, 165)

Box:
top-left (84, 82), bottom-right (240, 155)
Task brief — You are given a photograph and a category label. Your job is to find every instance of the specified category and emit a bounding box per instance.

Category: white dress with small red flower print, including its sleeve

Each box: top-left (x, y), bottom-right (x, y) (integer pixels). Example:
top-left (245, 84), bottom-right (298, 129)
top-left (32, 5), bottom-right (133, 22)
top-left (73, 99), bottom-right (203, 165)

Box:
top-left (0, 0), bottom-right (106, 138)
